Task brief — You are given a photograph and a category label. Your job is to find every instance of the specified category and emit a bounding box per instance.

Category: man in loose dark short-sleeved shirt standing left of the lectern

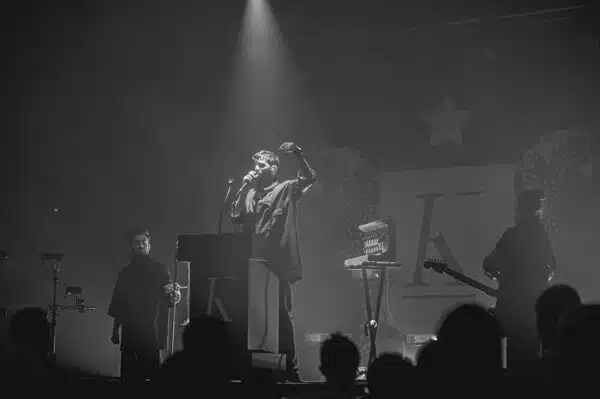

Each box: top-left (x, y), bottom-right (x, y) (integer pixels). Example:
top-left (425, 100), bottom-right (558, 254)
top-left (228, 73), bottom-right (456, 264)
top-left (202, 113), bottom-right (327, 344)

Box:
top-left (108, 229), bottom-right (181, 379)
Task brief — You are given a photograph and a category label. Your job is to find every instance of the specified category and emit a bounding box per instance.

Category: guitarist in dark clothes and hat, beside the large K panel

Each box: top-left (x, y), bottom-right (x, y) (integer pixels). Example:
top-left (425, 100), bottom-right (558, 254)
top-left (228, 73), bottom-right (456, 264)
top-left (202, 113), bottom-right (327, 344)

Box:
top-left (483, 190), bottom-right (556, 366)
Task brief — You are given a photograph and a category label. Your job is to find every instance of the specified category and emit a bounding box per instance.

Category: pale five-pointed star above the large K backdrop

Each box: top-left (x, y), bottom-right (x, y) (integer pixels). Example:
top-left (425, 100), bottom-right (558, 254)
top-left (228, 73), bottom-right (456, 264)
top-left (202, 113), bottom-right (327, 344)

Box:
top-left (423, 97), bottom-right (469, 147)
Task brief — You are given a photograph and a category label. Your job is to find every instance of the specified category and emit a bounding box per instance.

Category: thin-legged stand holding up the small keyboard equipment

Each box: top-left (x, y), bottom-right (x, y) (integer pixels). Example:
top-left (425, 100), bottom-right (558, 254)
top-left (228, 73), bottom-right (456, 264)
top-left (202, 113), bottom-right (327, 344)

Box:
top-left (351, 261), bottom-right (402, 368)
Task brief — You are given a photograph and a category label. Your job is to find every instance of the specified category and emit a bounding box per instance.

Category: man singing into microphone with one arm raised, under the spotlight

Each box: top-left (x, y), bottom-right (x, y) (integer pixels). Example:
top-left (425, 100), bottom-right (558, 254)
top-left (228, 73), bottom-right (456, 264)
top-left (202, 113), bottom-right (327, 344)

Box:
top-left (230, 143), bottom-right (315, 381)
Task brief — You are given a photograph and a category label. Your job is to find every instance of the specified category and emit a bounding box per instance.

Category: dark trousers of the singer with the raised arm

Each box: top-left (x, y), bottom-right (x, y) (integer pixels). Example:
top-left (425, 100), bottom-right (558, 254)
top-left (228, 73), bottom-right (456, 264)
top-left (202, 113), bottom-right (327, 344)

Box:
top-left (279, 281), bottom-right (298, 379)
